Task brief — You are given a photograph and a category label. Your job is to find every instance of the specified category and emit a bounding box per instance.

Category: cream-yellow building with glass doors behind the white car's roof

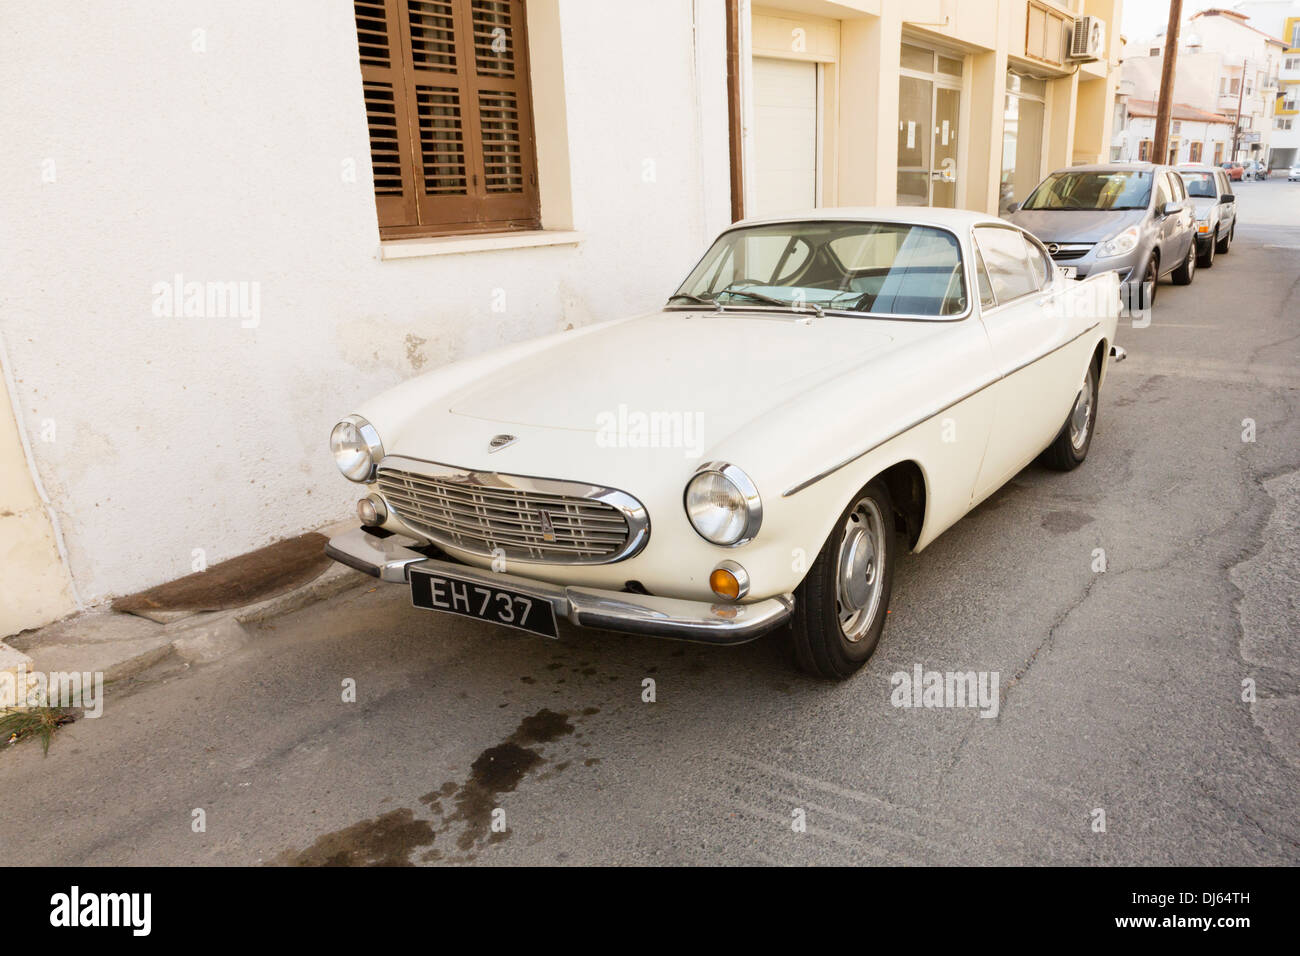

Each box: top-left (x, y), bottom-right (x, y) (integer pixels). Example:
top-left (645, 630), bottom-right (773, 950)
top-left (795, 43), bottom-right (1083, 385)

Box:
top-left (732, 0), bottom-right (1122, 216)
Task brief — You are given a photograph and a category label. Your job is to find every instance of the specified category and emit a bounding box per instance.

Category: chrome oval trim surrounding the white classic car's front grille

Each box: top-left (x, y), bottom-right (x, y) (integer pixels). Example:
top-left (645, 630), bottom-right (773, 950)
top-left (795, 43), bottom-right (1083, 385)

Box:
top-left (376, 455), bottom-right (650, 564)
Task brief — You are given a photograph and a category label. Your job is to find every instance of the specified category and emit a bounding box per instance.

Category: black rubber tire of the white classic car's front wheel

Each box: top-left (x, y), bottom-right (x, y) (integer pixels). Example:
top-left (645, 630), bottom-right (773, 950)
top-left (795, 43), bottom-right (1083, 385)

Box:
top-left (790, 479), bottom-right (898, 680)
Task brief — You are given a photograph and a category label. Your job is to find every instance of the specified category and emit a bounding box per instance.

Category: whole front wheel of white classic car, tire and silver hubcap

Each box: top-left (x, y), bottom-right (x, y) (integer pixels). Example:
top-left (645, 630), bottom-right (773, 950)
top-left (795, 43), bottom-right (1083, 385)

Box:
top-left (790, 479), bottom-right (898, 680)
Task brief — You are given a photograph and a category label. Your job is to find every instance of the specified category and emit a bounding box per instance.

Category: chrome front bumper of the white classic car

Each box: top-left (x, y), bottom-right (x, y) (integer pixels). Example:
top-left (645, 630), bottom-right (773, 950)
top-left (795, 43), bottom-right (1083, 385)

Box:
top-left (325, 528), bottom-right (794, 644)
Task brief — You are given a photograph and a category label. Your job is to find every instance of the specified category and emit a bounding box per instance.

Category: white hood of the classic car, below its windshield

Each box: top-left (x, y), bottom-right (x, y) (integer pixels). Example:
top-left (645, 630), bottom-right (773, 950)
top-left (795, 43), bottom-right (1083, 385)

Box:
top-left (446, 311), bottom-right (893, 438)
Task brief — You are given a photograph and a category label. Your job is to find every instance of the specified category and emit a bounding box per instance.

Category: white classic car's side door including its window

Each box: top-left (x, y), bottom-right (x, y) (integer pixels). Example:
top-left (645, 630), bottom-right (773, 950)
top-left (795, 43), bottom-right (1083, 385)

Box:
top-left (974, 225), bottom-right (1079, 501)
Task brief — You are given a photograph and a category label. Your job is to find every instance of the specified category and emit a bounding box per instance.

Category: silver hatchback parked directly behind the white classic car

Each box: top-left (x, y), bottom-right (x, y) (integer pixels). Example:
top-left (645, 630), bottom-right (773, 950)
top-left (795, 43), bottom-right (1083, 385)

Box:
top-left (1008, 163), bottom-right (1196, 308)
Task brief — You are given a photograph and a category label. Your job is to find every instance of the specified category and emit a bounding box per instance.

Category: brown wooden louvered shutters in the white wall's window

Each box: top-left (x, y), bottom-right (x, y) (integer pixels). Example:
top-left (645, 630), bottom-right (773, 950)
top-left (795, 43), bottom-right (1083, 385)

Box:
top-left (355, 0), bottom-right (540, 238)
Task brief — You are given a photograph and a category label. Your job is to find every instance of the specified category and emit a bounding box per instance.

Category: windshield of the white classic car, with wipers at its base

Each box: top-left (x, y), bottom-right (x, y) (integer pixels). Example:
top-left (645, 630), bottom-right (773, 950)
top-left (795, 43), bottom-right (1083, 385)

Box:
top-left (671, 222), bottom-right (966, 316)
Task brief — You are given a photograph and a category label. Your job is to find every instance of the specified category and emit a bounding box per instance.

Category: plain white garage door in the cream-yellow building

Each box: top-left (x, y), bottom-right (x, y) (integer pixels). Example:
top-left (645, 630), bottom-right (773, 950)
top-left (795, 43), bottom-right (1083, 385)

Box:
top-left (746, 57), bottom-right (818, 216)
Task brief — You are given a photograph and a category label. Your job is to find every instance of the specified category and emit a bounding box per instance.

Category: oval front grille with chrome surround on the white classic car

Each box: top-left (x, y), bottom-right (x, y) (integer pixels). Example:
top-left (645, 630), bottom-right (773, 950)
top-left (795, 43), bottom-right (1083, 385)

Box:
top-left (376, 457), bottom-right (650, 564)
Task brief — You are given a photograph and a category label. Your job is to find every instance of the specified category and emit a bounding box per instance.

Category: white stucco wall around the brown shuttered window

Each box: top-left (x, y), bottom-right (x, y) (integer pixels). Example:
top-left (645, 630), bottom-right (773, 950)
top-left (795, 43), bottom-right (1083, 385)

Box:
top-left (0, 0), bottom-right (729, 601)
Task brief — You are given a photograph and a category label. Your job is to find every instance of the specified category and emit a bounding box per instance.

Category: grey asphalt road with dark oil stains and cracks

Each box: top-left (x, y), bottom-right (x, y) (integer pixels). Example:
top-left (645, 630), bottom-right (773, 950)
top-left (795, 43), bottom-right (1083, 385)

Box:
top-left (0, 181), bottom-right (1300, 865)
